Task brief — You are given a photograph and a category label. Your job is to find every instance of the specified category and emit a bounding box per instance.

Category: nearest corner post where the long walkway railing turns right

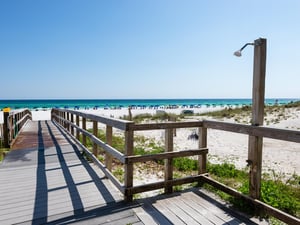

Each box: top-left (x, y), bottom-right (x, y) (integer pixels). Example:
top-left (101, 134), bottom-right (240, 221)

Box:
top-left (124, 130), bottom-right (133, 202)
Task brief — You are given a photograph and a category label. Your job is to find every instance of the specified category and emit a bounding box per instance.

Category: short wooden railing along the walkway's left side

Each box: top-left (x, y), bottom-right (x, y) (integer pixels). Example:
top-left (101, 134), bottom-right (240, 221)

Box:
top-left (2, 109), bottom-right (32, 148)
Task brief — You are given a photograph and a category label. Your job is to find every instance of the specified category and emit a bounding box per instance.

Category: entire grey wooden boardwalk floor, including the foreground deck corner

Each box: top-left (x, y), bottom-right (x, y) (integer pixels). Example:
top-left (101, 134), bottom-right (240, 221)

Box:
top-left (0, 121), bottom-right (265, 225)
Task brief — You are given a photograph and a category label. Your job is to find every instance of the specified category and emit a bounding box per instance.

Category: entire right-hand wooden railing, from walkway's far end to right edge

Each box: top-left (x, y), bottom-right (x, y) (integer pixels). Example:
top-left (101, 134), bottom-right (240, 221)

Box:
top-left (52, 109), bottom-right (300, 224)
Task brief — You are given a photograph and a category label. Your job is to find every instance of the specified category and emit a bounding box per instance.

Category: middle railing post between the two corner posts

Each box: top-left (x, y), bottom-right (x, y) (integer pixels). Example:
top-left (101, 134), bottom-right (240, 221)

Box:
top-left (165, 129), bottom-right (174, 194)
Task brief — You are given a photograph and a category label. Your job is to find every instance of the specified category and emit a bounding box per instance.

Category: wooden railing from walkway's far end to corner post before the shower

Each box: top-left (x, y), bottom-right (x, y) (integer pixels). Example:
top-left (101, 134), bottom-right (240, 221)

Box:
top-left (52, 109), bottom-right (208, 201)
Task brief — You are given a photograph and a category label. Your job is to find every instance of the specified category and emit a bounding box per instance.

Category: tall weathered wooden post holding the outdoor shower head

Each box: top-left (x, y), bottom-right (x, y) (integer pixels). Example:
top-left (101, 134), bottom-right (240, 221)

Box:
top-left (248, 38), bottom-right (267, 199)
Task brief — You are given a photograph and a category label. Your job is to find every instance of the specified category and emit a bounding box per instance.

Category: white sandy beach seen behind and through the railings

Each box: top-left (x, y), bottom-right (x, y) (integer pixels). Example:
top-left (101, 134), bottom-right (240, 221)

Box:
top-left (0, 107), bottom-right (300, 178)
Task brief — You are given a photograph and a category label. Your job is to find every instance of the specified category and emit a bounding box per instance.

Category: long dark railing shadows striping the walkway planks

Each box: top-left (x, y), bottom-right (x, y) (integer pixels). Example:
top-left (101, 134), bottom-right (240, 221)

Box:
top-left (33, 121), bottom-right (119, 224)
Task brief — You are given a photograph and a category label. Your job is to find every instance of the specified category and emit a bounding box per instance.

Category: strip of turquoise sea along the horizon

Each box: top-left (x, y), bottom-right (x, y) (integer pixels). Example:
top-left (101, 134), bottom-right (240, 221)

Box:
top-left (0, 98), bottom-right (300, 109)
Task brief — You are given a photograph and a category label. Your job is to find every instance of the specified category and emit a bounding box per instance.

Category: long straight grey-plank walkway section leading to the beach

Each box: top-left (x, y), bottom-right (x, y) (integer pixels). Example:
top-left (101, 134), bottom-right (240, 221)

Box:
top-left (0, 121), bottom-right (134, 224)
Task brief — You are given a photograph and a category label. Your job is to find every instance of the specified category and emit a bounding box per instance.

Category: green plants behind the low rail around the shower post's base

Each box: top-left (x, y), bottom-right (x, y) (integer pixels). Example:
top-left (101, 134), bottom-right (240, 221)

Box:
top-left (205, 163), bottom-right (300, 220)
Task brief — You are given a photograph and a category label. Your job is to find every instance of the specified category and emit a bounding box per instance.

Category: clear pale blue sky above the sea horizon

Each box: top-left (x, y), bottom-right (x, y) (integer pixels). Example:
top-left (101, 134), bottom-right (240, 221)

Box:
top-left (0, 0), bottom-right (300, 99)
